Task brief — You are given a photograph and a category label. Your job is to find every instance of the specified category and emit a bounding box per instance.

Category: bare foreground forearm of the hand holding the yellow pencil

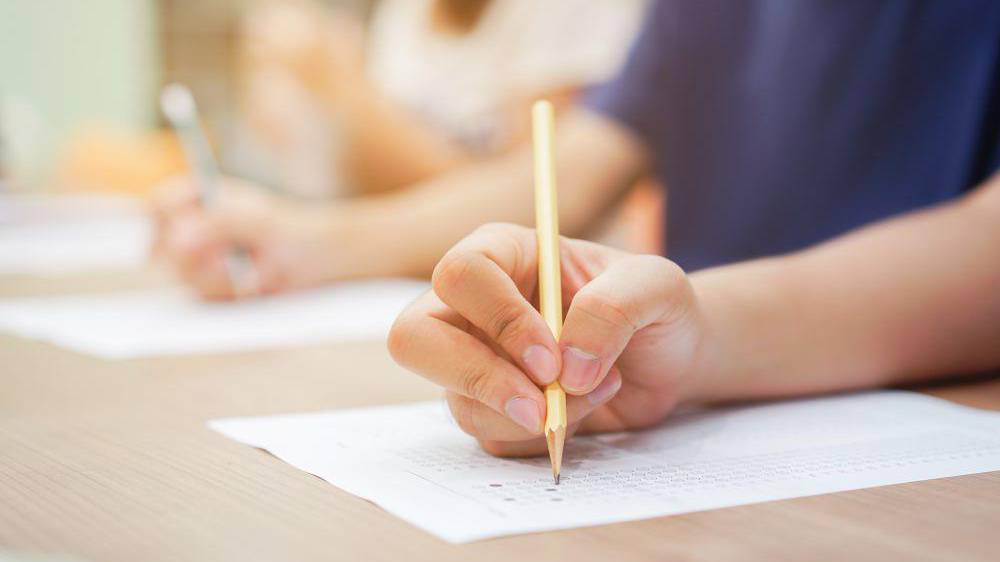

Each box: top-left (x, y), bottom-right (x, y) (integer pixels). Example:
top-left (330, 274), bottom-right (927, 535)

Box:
top-left (692, 180), bottom-right (1000, 400)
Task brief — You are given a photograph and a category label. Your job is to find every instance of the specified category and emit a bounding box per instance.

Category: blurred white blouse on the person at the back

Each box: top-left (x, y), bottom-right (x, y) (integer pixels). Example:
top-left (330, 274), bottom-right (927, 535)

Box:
top-left (367, 0), bottom-right (647, 153)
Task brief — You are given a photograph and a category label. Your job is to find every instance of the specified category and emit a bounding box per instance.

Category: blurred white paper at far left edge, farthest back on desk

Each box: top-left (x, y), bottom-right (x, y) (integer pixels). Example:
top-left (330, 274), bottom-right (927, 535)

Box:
top-left (0, 195), bottom-right (152, 275)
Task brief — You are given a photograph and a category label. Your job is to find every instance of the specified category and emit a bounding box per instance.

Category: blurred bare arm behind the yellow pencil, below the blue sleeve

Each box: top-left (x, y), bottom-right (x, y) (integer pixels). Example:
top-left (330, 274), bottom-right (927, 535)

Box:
top-left (324, 111), bottom-right (645, 276)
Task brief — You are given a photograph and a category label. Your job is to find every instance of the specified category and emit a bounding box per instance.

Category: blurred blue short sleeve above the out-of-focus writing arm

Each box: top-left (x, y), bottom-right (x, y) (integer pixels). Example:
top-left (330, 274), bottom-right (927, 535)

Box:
top-left (583, 2), bottom-right (670, 151)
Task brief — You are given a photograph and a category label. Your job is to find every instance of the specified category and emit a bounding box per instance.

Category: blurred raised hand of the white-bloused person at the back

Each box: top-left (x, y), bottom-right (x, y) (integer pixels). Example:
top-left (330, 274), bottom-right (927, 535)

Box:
top-left (242, 0), bottom-right (364, 96)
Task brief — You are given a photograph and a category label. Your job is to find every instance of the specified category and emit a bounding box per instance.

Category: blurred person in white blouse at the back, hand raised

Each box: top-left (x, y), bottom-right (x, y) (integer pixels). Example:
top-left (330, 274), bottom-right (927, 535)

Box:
top-left (229, 0), bottom-right (646, 197)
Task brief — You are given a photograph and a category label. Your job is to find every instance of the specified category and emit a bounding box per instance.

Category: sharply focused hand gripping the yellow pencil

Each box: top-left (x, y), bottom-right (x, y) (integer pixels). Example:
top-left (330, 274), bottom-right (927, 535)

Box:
top-left (389, 221), bottom-right (706, 456)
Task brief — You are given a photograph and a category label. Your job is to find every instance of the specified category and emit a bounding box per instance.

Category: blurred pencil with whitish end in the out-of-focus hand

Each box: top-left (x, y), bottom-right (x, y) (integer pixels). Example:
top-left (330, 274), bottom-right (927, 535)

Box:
top-left (160, 84), bottom-right (259, 296)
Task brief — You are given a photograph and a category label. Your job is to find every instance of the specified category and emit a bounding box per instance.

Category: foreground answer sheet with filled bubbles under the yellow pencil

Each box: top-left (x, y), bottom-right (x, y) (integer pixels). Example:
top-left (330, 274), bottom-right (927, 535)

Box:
top-left (209, 391), bottom-right (1000, 543)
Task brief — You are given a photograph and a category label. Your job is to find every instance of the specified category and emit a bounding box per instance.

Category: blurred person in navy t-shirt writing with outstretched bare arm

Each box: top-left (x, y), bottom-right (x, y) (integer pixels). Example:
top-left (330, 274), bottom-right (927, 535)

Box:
top-left (161, 0), bottom-right (1000, 304)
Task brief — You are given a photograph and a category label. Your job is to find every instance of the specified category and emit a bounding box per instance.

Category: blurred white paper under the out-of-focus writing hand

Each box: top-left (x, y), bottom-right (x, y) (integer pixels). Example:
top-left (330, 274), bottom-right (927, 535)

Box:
top-left (0, 280), bottom-right (428, 359)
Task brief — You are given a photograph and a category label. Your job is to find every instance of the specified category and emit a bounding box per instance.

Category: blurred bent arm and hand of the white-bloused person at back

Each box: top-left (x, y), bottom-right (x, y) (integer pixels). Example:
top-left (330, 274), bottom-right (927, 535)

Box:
top-left (241, 1), bottom-right (574, 194)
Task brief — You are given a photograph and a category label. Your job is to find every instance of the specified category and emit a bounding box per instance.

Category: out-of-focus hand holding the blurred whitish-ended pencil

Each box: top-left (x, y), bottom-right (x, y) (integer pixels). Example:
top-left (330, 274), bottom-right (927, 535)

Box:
top-left (153, 177), bottom-right (335, 299)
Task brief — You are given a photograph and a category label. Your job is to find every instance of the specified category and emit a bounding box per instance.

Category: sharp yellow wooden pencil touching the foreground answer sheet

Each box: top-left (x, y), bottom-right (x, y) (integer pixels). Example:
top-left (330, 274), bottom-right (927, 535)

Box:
top-left (531, 100), bottom-right (566, 484)
